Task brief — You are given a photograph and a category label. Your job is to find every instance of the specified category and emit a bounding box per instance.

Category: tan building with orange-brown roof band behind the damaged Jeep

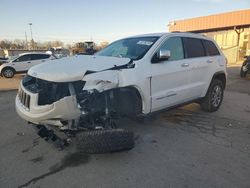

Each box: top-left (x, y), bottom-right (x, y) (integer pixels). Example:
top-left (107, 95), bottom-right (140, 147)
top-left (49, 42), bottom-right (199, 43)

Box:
top-left (168, 9), bottom-right (250, 63)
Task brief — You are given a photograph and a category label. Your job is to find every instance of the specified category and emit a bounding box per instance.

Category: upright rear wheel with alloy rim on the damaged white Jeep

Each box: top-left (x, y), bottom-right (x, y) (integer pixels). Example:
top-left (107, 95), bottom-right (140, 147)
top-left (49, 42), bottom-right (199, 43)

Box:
top-left (200, 79), bottom-right (224, 112)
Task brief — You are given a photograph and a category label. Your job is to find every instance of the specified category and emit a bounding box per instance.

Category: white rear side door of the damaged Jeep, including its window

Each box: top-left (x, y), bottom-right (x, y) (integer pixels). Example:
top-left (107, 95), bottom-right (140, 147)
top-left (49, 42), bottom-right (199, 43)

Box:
top-left (183, 37), bottom-right (209, 100)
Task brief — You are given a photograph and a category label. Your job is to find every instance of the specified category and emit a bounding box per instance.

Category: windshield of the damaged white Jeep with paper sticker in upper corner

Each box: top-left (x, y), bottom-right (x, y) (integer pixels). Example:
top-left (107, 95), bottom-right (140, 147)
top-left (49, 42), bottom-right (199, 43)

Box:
top-left (95, 37), bottom-right (159, 60)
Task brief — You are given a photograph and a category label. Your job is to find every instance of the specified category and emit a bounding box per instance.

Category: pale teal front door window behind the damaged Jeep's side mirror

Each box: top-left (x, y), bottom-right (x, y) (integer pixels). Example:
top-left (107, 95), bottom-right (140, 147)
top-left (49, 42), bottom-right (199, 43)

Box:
top-left (160, 37), bottom-right (184, 61)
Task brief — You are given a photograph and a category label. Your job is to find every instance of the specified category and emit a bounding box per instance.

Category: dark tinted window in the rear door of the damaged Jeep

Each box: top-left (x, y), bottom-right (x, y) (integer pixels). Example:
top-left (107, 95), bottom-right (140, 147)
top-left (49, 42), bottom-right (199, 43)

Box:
top-left (183, 38), bottom-right (206, 58)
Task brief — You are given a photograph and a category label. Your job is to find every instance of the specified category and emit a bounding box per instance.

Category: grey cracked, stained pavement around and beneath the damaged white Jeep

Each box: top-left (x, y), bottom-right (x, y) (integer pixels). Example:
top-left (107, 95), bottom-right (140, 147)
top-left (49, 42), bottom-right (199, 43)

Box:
top-left (0, 67), bottom-right (250, 188)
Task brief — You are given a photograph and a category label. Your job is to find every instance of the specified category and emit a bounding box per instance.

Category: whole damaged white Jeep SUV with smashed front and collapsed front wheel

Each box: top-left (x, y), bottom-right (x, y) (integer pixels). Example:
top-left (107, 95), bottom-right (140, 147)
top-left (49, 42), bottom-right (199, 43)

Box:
top-left (16, 32), bottom-right (226, 153)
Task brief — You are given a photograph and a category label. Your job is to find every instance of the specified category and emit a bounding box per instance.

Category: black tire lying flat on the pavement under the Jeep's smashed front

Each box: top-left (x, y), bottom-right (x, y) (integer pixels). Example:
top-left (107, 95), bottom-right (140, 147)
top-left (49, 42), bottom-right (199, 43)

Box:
top-left (76, 129), bottom-right (134, 153)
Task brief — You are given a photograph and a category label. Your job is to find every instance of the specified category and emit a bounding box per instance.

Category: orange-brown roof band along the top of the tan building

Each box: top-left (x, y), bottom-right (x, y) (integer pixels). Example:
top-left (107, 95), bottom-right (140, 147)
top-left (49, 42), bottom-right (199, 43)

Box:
top-left (169, 9), bottom-right (250, 32)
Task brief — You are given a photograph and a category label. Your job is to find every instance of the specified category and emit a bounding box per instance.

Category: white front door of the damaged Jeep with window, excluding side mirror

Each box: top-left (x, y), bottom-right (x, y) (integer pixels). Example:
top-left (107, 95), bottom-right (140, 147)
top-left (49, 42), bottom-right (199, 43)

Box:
top-left (151, 37), bottom-right (189, 111)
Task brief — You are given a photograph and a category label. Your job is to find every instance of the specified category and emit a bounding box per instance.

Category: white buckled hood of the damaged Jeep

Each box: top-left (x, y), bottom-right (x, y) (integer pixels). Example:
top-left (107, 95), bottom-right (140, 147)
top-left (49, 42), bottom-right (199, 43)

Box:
top-left (28, 55), bottom-right (130, 82)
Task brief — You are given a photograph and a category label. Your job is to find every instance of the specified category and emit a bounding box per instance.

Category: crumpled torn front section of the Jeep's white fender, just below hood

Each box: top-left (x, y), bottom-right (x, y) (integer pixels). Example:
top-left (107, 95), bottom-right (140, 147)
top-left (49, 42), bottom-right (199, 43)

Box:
top-left (83, 70), bottom-right (119, 92)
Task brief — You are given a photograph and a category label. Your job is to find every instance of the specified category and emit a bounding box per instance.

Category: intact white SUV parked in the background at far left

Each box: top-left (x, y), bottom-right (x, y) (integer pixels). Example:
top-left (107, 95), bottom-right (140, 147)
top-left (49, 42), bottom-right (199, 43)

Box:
top-left (0, 52), bottom-right (54, 78)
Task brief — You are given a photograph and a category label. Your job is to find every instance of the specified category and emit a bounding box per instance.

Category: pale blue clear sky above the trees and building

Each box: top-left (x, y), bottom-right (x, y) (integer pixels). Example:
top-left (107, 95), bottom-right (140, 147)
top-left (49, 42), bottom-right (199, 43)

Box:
top-left (0, 0), bottom-right (250, 43)
